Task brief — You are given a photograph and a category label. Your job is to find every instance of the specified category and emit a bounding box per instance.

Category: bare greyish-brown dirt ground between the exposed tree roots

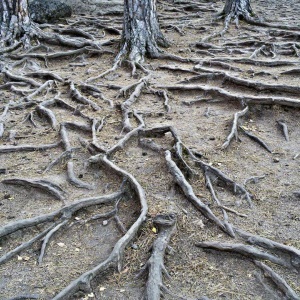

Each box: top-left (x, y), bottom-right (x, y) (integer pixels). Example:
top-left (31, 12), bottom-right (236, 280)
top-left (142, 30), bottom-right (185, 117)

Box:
top-left (0, 0), bottom-right (300, 300)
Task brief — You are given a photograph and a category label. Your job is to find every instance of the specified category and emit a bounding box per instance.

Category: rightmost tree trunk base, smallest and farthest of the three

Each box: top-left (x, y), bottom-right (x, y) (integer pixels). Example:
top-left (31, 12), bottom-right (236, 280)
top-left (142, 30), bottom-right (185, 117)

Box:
top-left (221, 0), bottom-right (254, 21)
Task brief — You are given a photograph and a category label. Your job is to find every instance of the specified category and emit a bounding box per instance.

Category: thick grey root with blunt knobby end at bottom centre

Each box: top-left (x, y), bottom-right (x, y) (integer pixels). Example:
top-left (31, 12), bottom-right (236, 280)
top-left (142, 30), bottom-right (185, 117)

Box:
top-left (142, 214), bottom-right (176, 300)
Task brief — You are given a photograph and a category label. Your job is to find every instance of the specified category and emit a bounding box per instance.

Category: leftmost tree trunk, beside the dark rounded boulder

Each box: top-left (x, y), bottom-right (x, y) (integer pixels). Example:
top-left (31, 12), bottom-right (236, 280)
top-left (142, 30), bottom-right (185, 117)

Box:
top-left (0, 0), bottom-right (31, 47)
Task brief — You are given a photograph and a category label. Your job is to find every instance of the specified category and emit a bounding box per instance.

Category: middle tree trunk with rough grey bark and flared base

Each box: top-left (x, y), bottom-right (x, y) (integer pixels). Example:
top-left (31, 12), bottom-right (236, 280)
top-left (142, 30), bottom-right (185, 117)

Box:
top-left (117, 0), bottom-right (168, 63)
